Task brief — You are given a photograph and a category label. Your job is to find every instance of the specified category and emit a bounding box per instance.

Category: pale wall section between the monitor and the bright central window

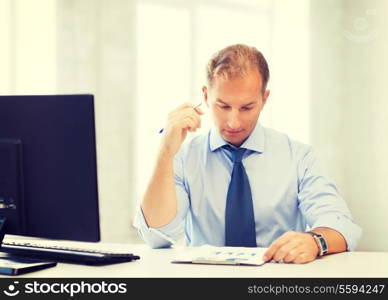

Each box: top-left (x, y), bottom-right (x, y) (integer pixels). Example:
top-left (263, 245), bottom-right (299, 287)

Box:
top-left (57, 0), bottom-right (138, 242)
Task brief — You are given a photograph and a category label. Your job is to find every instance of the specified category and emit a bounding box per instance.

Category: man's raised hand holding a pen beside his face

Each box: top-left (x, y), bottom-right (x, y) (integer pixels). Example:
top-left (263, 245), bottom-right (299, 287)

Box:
top-left (161, 104), bottom-right (203, 156)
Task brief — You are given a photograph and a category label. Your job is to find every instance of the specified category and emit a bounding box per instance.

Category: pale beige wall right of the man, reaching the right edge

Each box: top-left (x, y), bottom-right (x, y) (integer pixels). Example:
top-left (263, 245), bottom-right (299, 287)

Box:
top-left (311, 0), bottom-right (388, 251)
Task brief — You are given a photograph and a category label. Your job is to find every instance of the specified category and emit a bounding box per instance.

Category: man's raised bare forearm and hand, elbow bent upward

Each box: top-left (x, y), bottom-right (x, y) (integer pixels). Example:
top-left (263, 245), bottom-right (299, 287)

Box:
top-left (141, 104), bottom-right (203, 228)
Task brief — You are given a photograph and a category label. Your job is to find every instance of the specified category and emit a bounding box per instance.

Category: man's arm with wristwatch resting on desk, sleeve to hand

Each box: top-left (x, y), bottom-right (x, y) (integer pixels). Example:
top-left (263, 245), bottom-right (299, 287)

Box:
top-left (264, 148), bottom-right (361, 263)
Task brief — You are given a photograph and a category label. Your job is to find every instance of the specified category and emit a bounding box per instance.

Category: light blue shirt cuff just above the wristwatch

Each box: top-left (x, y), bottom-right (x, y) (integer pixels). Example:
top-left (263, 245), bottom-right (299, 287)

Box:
top-left (311, 214), bottom-right (362, 251)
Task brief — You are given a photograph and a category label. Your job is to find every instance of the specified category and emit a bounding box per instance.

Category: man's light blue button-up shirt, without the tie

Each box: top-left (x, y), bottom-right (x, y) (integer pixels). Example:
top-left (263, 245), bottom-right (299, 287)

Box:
top-left (135, 123), bottom-right (361, 250)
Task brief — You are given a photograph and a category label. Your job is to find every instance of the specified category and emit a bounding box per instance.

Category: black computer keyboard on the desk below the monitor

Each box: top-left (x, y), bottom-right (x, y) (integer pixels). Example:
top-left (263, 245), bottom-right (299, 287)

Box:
top-left (0, 242), bottom-right (140, 265)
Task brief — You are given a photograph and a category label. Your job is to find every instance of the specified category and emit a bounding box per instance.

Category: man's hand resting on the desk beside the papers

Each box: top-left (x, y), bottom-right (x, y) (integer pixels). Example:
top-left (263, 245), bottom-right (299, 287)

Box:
top-left (263, 231), bottom-right (319, 264)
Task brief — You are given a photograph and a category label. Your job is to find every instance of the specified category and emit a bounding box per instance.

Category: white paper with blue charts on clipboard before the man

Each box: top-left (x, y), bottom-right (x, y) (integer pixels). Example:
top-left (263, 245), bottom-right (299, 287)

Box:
top-left (171, 245), bottom-right (268, 266)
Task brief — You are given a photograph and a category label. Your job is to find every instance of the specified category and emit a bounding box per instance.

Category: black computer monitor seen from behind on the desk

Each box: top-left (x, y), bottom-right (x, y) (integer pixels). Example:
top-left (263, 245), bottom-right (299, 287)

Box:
top-left (0, 95), bottom-right (100, 242)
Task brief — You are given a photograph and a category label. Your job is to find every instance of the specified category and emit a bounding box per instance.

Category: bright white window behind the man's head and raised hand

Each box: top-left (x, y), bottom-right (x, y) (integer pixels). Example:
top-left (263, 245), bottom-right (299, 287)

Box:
top-left (135, 0), bottom-right (271, 200)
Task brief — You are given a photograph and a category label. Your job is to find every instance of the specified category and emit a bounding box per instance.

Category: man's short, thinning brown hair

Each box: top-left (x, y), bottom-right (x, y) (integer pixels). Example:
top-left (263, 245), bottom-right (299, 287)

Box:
top-left (206, 44), bottom-right (269, 93)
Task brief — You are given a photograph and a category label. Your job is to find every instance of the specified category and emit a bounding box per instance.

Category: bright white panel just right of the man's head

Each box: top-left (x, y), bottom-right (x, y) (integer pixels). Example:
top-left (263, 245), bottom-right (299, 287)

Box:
top-left (260, 0), bottom-right (311, 144)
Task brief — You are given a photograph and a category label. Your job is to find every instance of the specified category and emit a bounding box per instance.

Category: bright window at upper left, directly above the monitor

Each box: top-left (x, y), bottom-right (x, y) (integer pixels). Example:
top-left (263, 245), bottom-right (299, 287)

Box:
top-left (0, 0), bottom-right (57, 94)
